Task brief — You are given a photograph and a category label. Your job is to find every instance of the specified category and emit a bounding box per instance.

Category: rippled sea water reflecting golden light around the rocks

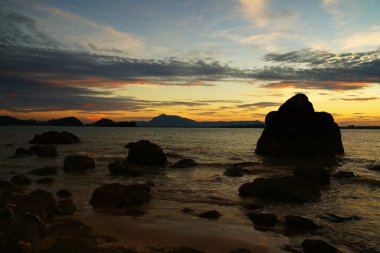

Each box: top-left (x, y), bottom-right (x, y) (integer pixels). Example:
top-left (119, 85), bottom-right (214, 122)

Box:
top-left (0, 126), bottom-right (380, 252)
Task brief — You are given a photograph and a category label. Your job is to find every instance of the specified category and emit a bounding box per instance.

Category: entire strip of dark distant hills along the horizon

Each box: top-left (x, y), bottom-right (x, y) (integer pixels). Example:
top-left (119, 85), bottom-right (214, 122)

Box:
top-left (0, 114), bottom-right (380, 129)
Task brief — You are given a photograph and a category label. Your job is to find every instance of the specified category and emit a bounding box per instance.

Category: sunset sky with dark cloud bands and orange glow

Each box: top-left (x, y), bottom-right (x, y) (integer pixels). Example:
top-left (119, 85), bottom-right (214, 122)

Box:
top-left (0, 0), bottom-right (380, 125)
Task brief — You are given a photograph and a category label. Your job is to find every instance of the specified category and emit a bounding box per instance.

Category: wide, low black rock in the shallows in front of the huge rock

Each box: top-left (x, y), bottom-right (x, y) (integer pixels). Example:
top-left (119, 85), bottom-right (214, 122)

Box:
top-left (239, 176), bottom-right (321, 203)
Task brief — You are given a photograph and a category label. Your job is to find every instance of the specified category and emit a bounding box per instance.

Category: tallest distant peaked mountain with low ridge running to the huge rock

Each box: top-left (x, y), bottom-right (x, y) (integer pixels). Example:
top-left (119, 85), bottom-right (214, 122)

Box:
top-left (137, 114), bottom-right (264, 127)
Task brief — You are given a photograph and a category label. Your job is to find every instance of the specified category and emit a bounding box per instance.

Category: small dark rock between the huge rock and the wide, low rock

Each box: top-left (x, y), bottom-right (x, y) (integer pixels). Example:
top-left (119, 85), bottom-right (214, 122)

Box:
top-left (293, 167), bottom-right (330, 185)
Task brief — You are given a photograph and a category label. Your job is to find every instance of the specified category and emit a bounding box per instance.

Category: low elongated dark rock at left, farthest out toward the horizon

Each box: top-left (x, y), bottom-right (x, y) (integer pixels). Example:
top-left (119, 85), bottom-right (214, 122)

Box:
top-left (29, 131), bottom-right (80, 144)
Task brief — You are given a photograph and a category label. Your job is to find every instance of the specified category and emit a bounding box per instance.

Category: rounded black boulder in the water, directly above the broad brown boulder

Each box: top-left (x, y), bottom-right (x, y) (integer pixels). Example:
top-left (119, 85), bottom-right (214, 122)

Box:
top-left (125, 140), bottom-right (167, 166)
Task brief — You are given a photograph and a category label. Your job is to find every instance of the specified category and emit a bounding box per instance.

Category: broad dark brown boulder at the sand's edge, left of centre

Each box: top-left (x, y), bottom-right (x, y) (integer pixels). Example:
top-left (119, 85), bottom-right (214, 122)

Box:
top-left (90, 183), bottom-right (151, 213)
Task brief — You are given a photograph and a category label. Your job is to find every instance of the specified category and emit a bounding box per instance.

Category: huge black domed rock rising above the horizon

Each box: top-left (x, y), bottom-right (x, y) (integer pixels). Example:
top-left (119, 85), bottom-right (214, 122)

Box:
top-left (255, 94), bottom-right (344, 157)
